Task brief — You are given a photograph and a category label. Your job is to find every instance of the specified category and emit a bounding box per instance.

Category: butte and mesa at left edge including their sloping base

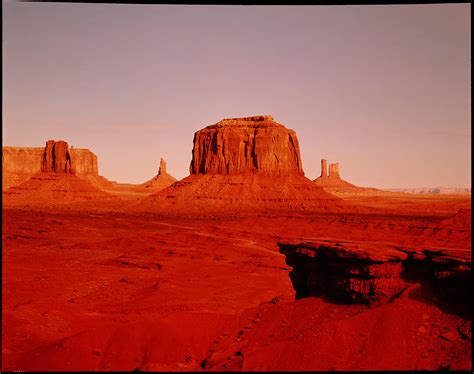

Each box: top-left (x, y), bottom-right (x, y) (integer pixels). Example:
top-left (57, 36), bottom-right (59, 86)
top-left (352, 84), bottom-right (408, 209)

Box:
top-left (2, 140), bottom-right (113, 206)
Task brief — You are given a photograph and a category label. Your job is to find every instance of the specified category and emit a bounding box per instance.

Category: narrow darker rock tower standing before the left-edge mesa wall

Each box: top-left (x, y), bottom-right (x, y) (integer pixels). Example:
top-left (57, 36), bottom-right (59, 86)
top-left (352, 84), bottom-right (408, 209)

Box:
top-left (41, 140), bottom-right (75, 174)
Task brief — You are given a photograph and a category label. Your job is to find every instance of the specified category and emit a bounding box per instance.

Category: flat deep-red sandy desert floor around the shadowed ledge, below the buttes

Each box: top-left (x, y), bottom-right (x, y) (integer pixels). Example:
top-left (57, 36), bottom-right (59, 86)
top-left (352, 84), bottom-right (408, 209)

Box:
top-left (2, 190), bottom-right (472, 371)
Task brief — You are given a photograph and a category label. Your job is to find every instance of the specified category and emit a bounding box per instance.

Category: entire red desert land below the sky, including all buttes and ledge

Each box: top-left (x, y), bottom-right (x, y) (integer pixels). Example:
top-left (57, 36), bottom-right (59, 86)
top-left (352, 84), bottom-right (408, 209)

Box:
top-left (2, 116), bottom-right (472, 371)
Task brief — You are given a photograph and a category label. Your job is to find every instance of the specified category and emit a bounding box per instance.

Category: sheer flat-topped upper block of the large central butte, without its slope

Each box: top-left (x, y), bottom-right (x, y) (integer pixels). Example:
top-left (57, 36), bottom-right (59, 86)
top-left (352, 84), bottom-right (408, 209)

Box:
top-left (190, 116), bottom-right (304, 175)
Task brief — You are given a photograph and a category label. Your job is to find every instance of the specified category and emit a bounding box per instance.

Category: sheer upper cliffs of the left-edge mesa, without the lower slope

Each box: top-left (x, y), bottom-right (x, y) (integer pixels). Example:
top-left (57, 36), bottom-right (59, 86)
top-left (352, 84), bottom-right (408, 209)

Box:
top-left (2, 140), bottom-right (98, 190)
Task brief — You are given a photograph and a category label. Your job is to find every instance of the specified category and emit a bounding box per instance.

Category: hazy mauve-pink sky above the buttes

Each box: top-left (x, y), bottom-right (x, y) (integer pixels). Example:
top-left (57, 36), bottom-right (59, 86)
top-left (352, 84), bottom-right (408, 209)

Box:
top-left (2, 0), bottom-right (471, 188)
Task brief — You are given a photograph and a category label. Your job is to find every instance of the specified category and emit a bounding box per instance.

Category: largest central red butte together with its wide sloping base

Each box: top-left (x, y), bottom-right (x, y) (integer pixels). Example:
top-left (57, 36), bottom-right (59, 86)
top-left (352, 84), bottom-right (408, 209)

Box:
top-left (136, 116), bottom-right (345, 214)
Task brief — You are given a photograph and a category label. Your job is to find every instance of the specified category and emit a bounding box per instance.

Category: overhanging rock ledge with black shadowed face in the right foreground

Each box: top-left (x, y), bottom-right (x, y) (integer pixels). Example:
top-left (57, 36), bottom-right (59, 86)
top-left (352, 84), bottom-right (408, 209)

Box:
top-left (278, 240), bottom-right (471, 304)
